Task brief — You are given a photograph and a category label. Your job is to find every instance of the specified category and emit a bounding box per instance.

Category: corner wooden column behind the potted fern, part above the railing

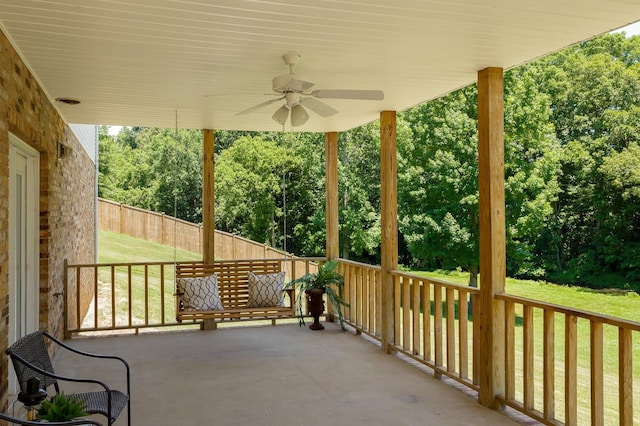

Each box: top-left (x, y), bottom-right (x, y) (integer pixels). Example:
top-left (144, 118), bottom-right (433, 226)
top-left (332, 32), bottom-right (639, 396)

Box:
top-left (324, 132), bottom-right (340, 259)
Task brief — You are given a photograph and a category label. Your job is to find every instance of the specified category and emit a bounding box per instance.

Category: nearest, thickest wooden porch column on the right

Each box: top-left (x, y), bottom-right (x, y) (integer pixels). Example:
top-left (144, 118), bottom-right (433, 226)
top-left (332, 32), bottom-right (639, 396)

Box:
top-left (474, 68), bottom-right (506, 409)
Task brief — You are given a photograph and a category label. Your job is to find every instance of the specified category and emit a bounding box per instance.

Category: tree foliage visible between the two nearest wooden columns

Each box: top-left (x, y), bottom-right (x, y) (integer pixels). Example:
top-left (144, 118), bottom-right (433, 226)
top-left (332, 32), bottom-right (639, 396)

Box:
top-left (398, 87), bottom-right (478, 284)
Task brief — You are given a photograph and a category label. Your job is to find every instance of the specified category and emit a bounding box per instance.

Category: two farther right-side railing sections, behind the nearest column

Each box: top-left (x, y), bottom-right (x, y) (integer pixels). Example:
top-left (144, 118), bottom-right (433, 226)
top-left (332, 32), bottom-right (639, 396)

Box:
top-left (340, 260), bottom-right (479, 390)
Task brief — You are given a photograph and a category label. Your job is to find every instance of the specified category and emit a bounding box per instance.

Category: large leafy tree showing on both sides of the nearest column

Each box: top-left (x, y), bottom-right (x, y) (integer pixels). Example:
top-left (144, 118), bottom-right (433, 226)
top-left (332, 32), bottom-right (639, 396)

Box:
top-left (399, 66), bottom-right (560, 286)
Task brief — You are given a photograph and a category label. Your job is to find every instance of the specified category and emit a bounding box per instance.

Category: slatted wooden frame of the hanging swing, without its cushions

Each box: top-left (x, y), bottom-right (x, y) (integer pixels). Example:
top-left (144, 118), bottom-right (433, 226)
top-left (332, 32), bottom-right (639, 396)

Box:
top-left (176, 259), bottom-right (295, 328)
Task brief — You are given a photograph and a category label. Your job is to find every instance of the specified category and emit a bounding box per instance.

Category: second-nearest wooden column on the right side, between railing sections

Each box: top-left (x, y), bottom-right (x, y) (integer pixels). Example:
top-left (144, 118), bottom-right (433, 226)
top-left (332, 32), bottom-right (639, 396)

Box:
top-left (380, 111), bottom-right (398, 352)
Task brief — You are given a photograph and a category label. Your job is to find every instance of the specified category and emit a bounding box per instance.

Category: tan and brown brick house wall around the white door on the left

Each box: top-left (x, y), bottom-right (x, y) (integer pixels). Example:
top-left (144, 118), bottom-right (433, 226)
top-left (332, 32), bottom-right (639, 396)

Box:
top-left (0, 28), bottom-right (96, 409)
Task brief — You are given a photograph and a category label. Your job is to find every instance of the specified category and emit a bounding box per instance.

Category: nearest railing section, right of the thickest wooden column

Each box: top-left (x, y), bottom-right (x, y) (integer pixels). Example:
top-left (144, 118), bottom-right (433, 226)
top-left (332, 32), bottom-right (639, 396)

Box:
top-left (496, 294), bottom-right (640, 425)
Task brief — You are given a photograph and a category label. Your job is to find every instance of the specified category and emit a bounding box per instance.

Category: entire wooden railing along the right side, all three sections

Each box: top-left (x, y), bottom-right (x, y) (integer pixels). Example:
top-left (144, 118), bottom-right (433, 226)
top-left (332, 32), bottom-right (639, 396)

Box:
top-left (340, 260), bottom-right (640, 425)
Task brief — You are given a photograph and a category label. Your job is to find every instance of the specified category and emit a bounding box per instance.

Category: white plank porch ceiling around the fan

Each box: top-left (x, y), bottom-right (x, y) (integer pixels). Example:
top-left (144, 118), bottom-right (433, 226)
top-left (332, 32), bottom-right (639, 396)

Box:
top-left (0, 0), bottom-right (640, 132)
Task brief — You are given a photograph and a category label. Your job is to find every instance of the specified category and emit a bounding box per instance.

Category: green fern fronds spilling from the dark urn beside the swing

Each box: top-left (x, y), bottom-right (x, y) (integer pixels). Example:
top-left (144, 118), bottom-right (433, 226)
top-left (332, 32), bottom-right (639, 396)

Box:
top-left (286, 260), bottom-right (349, 330)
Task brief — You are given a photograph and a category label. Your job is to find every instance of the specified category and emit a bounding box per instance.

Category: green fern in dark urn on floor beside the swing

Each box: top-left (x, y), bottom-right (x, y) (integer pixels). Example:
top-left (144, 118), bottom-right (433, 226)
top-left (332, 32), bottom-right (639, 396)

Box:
top-left (286, 260), bottom-right (349, 330)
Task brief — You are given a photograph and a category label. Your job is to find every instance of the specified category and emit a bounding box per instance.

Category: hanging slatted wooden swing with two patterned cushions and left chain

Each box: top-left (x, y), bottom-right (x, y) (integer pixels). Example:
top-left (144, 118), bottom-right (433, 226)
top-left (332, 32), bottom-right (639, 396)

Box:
top-left (174, 112), bottom-right (296, 330)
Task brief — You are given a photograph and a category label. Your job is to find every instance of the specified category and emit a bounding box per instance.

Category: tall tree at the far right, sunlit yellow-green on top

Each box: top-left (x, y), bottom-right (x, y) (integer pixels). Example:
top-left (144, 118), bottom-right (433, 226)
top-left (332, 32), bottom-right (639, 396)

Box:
top-left (539, 34), bottom-right (640, 286)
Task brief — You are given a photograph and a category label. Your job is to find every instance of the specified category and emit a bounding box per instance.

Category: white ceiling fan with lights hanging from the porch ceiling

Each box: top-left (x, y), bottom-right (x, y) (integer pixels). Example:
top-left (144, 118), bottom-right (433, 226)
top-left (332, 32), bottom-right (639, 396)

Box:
top-left (236, 53), bottom-right (384, 127)
